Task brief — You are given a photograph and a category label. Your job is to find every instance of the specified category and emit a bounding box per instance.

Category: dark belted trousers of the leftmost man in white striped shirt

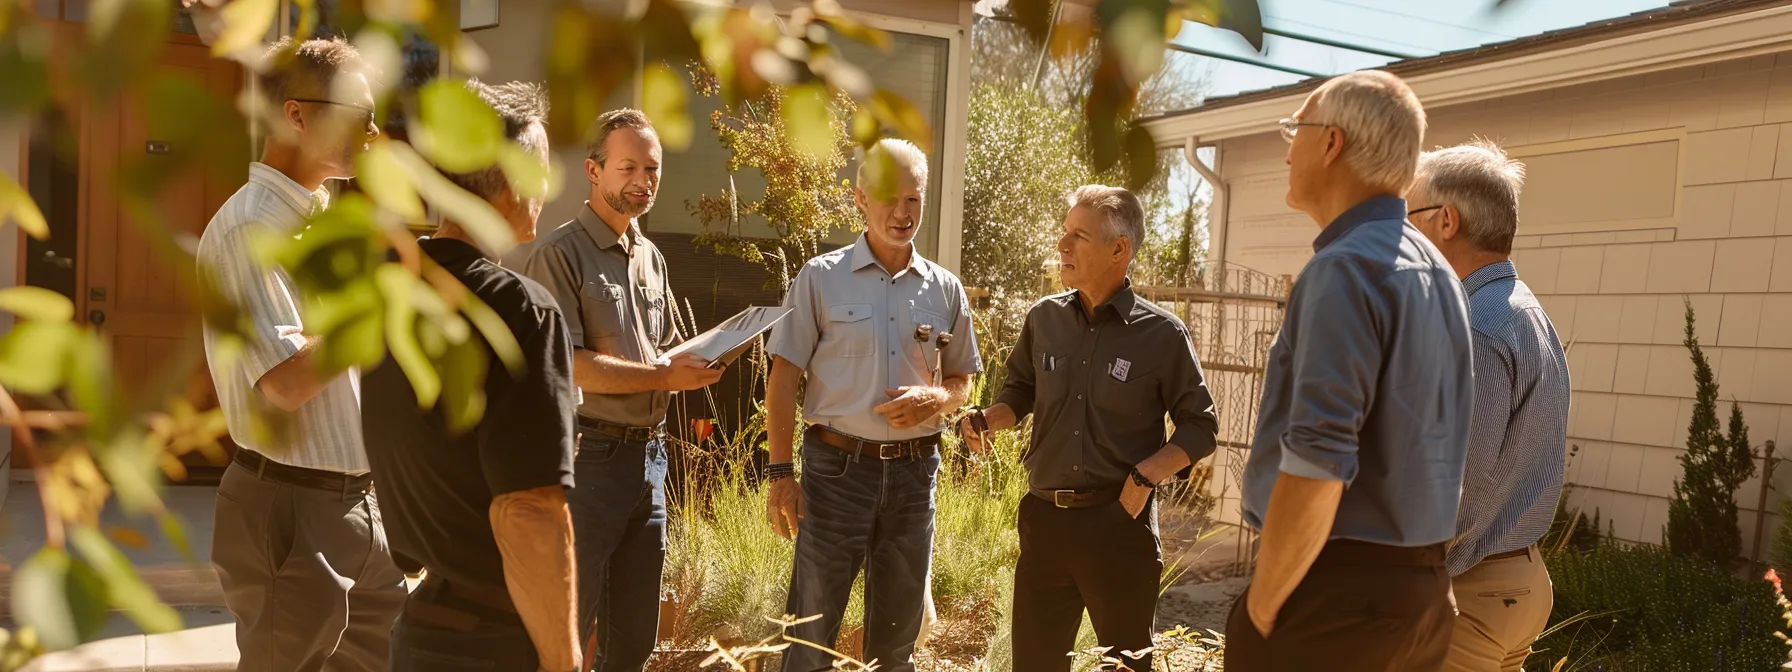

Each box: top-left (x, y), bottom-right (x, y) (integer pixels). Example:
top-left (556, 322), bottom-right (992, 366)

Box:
top-left (211, 464), bottom-right (405, 672)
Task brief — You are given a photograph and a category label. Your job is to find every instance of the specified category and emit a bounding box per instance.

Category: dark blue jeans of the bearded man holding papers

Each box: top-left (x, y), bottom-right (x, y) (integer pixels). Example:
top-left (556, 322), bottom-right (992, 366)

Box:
top-left (566, 432), bottom-right (667, 672)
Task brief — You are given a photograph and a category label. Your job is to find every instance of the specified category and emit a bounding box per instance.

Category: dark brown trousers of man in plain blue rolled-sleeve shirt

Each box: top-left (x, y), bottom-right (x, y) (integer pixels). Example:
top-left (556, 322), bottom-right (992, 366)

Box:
top-left (1226, 539), bottom-right (1455, 672)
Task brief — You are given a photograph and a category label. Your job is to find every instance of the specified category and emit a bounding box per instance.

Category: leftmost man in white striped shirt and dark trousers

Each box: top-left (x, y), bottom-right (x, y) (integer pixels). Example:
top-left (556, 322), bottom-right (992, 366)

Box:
top-left (197, 39), bottom-right (405, 672)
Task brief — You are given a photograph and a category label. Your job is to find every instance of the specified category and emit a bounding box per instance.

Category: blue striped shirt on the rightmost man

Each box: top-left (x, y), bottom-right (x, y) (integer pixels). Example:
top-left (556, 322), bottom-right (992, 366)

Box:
top-left (1446, 262), bottom-right (1568, 575)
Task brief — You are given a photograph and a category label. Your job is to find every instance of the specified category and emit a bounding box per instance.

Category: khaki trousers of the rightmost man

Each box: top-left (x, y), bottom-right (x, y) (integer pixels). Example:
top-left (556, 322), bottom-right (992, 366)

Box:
top-left (1444, 547), bottom-right (1555, 672)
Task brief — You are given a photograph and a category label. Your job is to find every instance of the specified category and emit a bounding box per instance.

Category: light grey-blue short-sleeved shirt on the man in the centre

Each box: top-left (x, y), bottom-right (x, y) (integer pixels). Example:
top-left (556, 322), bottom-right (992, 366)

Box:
top-left (769, 235), bottom-right (982, 441)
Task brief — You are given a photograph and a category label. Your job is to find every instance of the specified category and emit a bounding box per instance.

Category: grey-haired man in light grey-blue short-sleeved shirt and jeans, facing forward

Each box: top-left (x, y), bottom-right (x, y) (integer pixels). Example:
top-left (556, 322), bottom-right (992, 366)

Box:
top-left (765, 140), bottom-right (980, 672)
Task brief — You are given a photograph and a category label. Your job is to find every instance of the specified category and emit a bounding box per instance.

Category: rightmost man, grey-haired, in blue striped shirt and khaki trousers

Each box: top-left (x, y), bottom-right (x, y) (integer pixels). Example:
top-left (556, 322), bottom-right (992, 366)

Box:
top-left (1407, 142), bottom-right (1568, 672)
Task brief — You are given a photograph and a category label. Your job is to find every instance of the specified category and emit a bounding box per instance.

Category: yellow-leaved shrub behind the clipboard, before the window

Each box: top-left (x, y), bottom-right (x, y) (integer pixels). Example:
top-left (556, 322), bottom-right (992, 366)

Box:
top-left (686, 68), bottom-right (856, 292)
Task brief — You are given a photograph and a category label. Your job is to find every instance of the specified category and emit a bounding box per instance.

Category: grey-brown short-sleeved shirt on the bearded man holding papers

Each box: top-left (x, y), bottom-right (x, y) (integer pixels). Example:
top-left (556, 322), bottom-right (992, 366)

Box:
top-left (523, 202), bottom-right (683, 426)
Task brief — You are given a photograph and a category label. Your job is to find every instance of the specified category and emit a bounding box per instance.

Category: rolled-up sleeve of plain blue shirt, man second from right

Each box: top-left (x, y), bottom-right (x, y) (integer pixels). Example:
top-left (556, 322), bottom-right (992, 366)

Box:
top-left (1279, 258), bottom-right (1383, 486)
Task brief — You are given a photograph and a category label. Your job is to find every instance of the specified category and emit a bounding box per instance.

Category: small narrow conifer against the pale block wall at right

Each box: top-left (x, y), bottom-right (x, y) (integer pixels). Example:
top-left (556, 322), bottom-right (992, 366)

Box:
top-left (1667, 301), bottom-right (1754, 564)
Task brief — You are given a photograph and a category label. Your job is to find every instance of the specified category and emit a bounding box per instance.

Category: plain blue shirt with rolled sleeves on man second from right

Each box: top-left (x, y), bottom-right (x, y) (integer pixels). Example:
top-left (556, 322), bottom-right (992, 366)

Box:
top-left (1244, 197), bottom-right (1475, 547)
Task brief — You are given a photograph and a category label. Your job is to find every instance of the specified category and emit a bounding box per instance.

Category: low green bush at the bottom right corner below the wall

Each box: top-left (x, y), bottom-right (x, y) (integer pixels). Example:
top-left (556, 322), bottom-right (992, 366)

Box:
top-left (1536, 545), bottom-right (1785, 672)
